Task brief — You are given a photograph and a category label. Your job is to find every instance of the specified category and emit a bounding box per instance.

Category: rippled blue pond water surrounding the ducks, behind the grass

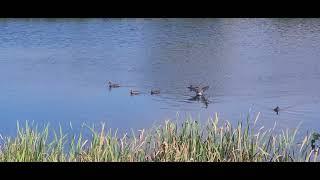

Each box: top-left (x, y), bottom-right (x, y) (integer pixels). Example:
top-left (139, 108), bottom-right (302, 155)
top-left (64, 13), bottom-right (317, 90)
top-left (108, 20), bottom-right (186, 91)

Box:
top-left (0, 19), bottom-right (320, 135)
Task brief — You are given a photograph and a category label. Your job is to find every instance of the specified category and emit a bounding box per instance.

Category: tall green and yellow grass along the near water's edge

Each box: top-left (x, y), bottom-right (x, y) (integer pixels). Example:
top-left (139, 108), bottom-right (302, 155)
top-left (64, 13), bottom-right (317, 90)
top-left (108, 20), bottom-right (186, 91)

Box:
top-left (0, 113), bottom-right (320, 162)
